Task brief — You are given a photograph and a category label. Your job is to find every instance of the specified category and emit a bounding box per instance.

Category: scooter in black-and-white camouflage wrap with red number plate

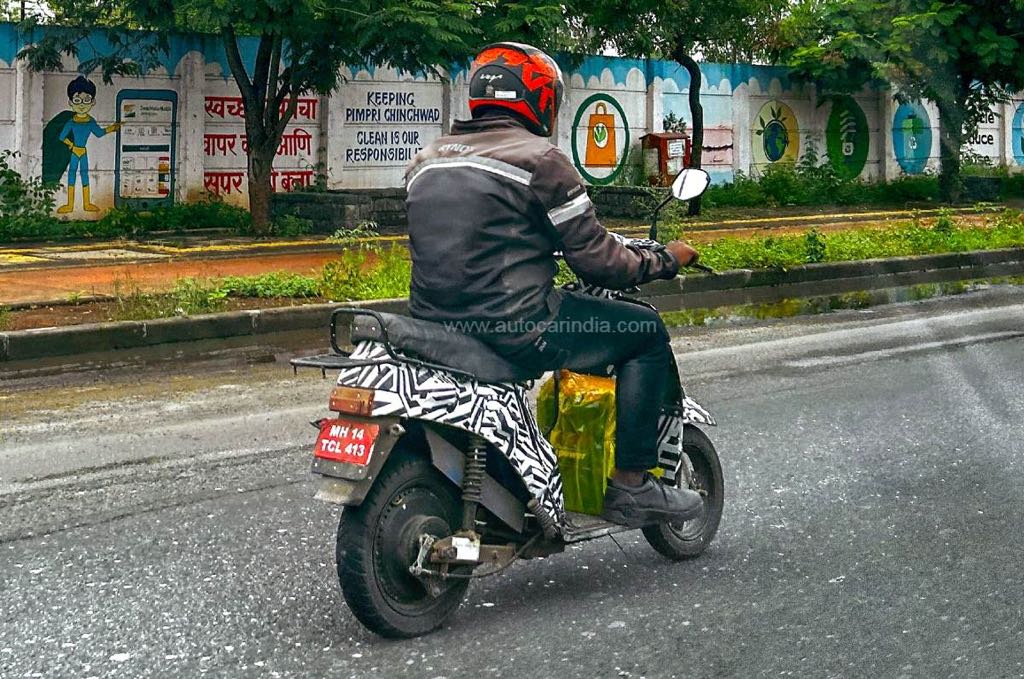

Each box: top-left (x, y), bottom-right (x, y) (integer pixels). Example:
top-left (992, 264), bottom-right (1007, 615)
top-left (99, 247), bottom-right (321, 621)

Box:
top-left (292, 170), bottom-right (724, 637)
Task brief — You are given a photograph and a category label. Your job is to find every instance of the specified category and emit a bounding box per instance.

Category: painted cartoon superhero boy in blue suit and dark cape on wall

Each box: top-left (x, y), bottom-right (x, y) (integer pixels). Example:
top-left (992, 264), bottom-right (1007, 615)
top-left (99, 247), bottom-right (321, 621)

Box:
top-left (43, 76), bottom-right (121, 214)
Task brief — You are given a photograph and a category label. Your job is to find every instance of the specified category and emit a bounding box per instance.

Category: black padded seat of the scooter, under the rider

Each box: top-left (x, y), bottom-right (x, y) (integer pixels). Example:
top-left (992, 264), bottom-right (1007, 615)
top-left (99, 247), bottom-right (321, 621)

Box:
top-left (351, 313), bottom-right (544, 383)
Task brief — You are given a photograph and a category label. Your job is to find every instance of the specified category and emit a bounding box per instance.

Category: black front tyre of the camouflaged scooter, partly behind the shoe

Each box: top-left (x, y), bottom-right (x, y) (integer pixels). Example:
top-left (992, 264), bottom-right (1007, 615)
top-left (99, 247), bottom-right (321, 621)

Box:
top-left (643, 425), bottom-right (725, 561)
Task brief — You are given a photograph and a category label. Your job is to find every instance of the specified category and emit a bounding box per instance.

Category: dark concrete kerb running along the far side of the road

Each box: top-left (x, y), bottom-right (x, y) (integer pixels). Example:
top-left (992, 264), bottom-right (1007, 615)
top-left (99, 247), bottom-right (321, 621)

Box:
top-left (0, 248), bottom-right (1024, 363)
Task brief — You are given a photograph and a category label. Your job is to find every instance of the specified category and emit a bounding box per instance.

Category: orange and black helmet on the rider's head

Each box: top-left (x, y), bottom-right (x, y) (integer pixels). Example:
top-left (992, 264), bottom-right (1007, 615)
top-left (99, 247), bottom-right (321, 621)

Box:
top-left (469, 42), bottom-right (565, 137)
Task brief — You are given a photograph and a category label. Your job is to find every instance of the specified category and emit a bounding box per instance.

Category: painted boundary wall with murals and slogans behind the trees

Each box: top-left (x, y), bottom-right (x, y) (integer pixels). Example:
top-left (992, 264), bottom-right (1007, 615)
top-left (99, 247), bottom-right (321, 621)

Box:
top-left (0, 24), bottom-right (1024, 219)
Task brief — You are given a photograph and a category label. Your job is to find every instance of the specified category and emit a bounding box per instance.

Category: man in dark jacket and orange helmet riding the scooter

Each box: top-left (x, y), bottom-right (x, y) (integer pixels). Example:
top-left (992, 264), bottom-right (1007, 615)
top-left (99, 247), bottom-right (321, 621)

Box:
top-left (406, 43), bottom-right (701, 526)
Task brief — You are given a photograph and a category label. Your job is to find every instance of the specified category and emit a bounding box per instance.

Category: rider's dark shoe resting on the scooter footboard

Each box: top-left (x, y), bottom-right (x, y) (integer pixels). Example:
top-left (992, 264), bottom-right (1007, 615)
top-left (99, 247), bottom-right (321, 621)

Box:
top-left (601, 474), bottom-right (703, 528)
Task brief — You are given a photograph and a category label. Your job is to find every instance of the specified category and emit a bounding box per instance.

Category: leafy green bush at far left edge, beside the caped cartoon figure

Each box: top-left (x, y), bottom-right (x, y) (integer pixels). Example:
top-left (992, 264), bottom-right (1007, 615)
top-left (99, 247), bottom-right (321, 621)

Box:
top-left (0, 151), bottom-right (58, 241)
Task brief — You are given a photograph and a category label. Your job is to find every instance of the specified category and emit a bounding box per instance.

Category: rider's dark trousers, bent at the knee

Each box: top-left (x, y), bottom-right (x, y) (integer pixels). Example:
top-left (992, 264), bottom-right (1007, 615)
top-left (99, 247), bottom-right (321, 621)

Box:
top-left (494, 293), bottom-right (679, 471)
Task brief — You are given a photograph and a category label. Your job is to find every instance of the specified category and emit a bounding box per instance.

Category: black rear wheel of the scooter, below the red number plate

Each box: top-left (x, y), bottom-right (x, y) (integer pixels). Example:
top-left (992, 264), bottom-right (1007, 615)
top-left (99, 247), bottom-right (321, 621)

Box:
top-left (336, 451), bottom-right (469, 638)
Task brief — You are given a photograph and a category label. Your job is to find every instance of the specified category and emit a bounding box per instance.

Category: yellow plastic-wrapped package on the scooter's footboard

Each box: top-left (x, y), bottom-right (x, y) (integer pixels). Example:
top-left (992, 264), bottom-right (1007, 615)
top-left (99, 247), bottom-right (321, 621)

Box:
top-left (537, 370), bottom-right (664, 516)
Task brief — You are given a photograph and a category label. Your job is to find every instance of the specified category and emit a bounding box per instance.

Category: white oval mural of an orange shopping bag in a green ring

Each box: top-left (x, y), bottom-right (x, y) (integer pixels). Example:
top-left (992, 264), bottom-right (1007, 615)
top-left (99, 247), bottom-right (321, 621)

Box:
top-left (570, 92), bottom-right (630, 184)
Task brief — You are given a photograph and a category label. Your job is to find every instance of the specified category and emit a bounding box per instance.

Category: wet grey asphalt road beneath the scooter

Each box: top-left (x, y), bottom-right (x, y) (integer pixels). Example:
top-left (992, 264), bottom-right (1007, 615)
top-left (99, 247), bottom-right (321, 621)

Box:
top-left (0, 291), bottom-right (1024, 678)
